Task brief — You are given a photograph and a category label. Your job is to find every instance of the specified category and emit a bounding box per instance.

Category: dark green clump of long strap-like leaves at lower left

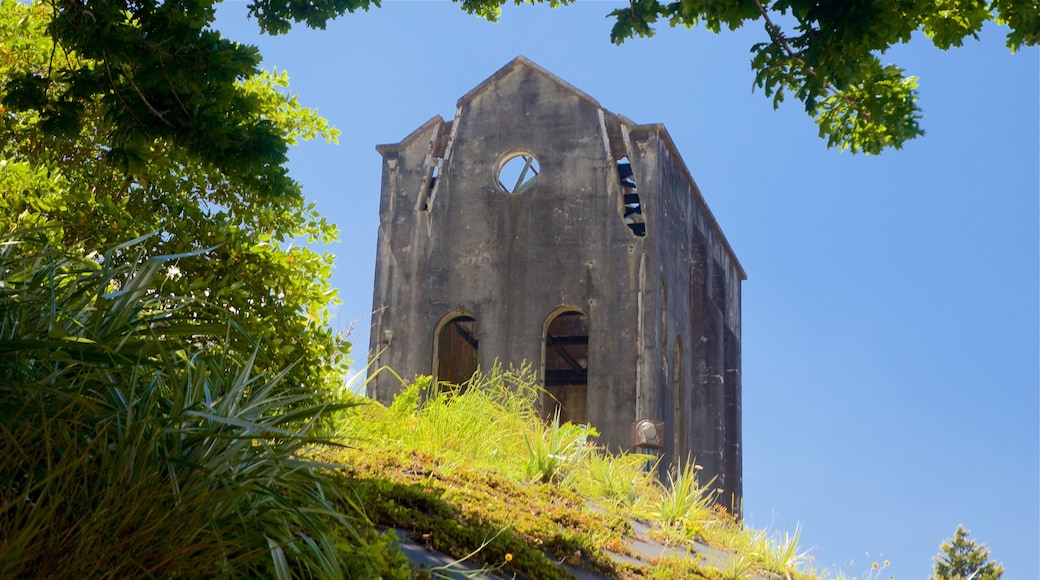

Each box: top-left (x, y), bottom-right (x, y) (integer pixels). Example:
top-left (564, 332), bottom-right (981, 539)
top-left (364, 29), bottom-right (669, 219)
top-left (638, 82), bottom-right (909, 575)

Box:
top-left (0, 238), bottom-right (404, 578)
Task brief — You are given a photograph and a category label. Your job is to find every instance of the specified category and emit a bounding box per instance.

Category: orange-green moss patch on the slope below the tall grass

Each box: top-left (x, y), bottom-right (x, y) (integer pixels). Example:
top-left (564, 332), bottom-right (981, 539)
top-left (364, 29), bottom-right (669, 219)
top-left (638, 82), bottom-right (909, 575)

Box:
top-left (321, 449), bottom-right (631, 579)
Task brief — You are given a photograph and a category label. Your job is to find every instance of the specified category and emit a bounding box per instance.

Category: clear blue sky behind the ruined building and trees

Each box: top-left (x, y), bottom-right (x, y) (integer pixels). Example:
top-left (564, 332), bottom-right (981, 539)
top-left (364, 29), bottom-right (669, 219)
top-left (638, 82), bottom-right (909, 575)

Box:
top-left (218, 1), bottom-right (1040, 580)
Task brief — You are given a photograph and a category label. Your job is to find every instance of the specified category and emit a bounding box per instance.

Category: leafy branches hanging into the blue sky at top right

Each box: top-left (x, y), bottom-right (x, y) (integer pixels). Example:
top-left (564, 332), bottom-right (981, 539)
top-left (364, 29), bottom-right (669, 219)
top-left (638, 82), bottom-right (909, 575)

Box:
top-left (609, 0), bottom-right (1027, 154)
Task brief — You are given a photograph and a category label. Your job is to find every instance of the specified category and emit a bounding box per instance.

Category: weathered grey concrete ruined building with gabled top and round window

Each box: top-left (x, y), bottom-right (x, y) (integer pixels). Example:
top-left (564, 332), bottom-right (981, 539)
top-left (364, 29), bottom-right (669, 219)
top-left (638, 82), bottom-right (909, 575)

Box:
top-left (369, 56), bottom-right (746, 502)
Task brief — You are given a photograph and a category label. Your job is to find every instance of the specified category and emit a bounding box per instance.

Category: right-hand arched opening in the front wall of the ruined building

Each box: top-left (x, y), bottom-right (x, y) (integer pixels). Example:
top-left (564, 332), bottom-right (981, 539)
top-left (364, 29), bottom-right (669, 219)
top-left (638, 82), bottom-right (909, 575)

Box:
top-left (542, 312), bottom-right (589, 423)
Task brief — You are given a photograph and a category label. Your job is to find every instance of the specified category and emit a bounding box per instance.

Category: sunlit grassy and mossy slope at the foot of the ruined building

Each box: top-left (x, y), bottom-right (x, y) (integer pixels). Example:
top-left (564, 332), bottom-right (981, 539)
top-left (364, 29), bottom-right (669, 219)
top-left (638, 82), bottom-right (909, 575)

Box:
top-left (328, 367), bottom-right (823, 578)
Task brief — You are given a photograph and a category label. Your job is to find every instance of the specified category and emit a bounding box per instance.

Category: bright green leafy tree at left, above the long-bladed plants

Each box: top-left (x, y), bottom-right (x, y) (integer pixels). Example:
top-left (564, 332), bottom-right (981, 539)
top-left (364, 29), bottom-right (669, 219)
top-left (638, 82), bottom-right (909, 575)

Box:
top-left (0, 0), bottom-right (348, 399)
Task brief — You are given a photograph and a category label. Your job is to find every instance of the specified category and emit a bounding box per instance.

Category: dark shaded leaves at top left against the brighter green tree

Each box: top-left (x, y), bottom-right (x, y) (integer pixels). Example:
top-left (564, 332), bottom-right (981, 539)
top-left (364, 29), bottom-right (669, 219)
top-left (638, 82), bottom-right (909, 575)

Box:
top-left (42, 0), bottom-right (278, 190)
